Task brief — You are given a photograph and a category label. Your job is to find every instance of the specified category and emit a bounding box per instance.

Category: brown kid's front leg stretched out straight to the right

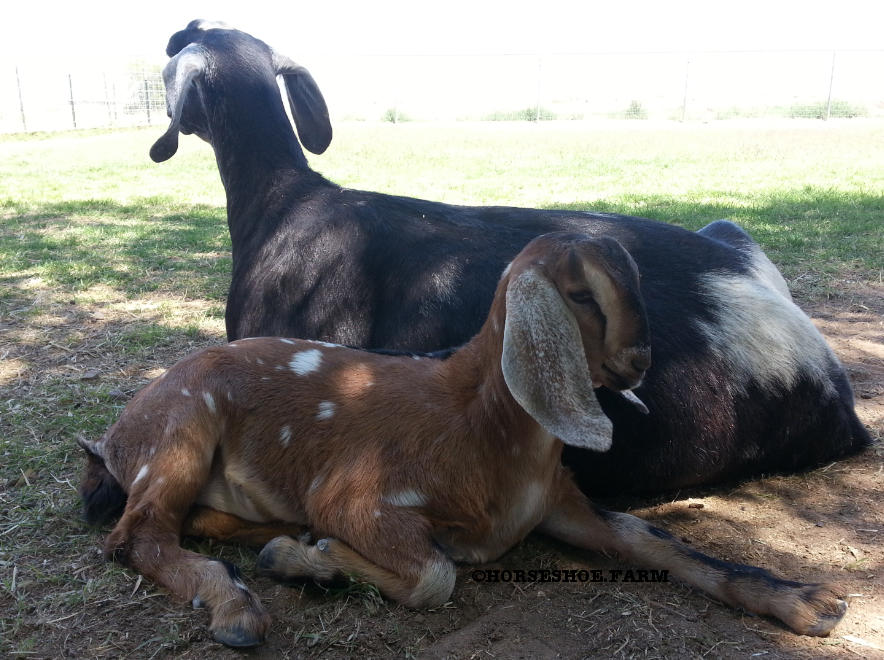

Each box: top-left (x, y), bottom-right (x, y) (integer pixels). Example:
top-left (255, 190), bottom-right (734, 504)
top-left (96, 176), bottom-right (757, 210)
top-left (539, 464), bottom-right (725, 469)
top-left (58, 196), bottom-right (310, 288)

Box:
top-left (537, 477), bottom-right (847, 636)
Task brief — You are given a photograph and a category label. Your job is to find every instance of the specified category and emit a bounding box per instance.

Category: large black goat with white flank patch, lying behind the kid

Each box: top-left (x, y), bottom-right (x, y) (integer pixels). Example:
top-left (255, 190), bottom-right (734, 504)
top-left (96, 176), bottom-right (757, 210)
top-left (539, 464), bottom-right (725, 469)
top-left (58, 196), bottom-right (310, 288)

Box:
top-left (151, 21), bottom-right (869, 493)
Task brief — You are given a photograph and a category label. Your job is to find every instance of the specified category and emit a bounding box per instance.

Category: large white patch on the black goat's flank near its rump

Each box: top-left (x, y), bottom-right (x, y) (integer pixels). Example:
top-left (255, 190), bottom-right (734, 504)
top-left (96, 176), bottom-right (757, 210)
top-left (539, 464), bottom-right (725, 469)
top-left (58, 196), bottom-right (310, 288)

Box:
top-left (697, 273), bottom-right (838, 395)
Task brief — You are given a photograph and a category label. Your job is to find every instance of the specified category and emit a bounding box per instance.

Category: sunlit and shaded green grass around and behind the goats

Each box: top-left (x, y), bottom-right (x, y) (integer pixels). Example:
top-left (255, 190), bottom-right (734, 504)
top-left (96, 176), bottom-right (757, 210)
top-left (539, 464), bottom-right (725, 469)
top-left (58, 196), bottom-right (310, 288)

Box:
top-left (0, 121), bottom-right (884, 657)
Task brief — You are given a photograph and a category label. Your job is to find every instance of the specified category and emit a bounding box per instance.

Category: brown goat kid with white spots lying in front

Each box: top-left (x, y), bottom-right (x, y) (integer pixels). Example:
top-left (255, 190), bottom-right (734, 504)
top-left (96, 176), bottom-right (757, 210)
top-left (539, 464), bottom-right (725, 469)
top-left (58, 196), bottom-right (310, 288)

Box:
top-left (81, 234), bottom-right (846, 646)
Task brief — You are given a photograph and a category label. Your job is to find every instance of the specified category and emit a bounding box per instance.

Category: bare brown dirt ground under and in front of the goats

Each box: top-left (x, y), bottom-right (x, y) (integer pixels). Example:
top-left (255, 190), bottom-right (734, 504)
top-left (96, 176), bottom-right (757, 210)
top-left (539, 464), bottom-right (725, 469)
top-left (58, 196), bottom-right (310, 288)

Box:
top-left (0, 285), bottom-right (884, 659)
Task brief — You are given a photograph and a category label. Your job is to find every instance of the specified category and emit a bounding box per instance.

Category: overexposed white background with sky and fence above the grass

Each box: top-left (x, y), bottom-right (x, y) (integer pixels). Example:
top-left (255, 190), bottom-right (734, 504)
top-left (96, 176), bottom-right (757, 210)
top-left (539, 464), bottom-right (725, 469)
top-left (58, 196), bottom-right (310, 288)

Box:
top-left (0, 0), bottom-right (884, 133)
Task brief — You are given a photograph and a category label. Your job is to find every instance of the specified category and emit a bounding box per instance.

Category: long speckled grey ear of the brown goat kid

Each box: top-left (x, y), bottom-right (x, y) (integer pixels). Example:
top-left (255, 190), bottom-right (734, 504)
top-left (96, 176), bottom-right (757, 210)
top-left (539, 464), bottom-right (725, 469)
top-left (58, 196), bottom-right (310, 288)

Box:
top-left (501, 269), bottom-right (614, 451)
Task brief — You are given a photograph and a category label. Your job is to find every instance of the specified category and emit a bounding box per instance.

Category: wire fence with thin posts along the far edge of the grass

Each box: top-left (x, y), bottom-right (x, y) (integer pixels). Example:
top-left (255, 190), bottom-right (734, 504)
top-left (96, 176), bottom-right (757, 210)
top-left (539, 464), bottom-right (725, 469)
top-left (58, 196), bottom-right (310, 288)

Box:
top-left (0, 50), bottom-right (884, 133)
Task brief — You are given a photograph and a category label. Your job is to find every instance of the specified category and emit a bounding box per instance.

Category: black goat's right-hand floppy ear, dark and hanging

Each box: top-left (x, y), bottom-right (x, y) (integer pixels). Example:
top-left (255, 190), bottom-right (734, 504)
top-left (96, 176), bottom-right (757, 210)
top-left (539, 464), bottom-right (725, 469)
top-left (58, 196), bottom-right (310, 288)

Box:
top-left (273, 52), bottom-right (332, 154)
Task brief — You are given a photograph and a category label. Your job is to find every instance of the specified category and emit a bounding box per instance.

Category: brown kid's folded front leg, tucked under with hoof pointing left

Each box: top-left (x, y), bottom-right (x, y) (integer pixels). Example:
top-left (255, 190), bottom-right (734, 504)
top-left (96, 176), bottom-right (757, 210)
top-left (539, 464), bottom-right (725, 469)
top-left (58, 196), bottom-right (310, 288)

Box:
top-left (257, 536), bottom-right (456, 607)
